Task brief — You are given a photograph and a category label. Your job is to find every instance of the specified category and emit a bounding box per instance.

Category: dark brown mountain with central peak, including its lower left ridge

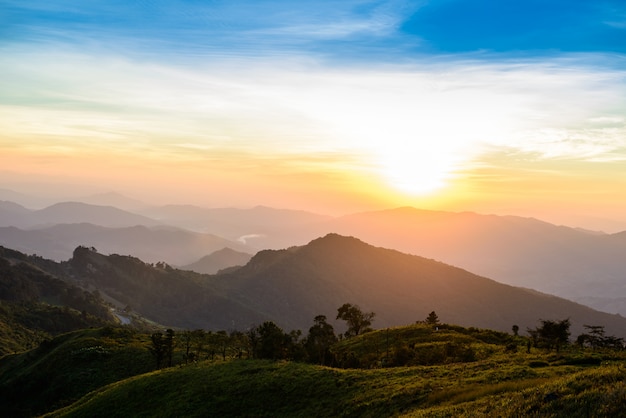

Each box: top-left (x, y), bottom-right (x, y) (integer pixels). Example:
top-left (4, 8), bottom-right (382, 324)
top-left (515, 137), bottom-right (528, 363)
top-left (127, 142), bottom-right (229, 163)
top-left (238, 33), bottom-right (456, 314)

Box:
top-left (50, 234), bottom-right (626, 336)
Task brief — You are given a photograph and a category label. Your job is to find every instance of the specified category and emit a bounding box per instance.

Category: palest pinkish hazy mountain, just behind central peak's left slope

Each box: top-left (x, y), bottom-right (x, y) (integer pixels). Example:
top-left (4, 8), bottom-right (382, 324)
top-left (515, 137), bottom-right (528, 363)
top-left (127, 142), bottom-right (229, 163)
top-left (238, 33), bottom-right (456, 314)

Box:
top-left (141, 205), bottom-right (332, 249)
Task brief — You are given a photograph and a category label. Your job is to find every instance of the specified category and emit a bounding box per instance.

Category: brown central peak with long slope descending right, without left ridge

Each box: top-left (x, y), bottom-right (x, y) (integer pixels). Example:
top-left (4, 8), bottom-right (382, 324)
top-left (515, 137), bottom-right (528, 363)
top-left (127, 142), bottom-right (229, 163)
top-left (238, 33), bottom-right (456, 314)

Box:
top-left (220, 234), bottom-right (626, 335)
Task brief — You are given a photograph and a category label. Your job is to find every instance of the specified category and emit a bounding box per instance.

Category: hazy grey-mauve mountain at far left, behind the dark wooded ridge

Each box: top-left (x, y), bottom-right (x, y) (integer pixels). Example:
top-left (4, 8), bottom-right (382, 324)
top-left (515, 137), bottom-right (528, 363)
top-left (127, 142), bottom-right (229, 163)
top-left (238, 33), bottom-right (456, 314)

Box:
top-left (0, 223), bottom-right (249, 265)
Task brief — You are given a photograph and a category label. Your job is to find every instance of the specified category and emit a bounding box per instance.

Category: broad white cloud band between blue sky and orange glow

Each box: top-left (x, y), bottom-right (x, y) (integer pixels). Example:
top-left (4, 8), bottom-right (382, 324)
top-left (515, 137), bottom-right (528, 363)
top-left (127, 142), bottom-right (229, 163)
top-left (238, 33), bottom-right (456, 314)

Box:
top-left (0, 51), bottom-right (626, 176)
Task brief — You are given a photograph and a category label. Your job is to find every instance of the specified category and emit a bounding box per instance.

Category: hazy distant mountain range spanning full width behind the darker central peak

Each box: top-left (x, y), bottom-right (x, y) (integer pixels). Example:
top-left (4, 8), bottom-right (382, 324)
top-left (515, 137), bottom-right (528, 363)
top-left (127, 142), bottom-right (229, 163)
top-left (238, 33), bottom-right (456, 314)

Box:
top-left (0, 195), bottom-right (626, 315)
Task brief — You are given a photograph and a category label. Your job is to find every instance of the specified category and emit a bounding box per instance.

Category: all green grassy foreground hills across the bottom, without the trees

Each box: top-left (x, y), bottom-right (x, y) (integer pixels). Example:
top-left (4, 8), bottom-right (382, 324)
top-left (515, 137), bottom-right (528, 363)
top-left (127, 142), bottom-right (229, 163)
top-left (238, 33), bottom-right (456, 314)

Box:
top-left (0, 324), bottom-right (608, 417)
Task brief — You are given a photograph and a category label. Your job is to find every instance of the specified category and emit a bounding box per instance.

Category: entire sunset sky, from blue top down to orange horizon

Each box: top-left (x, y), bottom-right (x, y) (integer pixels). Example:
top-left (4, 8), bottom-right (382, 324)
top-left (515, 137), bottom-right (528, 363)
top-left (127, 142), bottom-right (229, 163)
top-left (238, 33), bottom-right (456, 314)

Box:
top-left (0, 0), bottom-right (626, 232)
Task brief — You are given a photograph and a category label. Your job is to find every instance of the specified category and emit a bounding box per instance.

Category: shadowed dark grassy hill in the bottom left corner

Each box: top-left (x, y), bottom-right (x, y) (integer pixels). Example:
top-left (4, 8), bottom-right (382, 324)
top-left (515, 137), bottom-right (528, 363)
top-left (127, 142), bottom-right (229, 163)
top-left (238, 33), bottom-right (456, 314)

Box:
top-left (0, 327), bottom-right (154, 417)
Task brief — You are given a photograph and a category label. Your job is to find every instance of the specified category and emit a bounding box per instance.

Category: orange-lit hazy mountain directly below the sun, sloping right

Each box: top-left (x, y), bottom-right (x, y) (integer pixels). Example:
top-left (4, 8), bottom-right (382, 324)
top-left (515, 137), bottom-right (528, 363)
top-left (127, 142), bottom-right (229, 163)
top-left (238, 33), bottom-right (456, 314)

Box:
top-left (320, 208), bottom-right (626, 314)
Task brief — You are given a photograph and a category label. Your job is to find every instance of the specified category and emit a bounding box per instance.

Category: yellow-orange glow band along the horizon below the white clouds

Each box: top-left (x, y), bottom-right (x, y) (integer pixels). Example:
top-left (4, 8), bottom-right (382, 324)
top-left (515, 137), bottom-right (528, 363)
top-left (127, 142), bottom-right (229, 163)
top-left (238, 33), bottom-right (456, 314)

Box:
top-left (0, 137), bottom-right (626, 233)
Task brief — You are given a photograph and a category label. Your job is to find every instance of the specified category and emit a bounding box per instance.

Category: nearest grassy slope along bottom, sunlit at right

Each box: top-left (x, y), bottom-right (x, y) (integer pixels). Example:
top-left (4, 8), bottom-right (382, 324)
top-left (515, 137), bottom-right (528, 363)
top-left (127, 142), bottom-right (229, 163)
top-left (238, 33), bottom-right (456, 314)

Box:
top-left (47, 353), bottom-right (626, 417)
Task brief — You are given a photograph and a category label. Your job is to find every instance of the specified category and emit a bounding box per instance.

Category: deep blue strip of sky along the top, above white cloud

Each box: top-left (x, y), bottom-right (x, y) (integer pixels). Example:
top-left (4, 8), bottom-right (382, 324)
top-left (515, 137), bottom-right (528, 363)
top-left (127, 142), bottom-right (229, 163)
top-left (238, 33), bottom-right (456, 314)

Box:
top-left (0, 0), bottom-right (626, 61)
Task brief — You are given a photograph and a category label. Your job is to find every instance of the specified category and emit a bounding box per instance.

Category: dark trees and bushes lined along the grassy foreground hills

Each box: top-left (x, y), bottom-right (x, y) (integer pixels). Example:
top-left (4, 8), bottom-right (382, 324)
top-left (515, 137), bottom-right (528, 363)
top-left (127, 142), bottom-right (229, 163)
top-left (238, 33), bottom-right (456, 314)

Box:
top-left (150, 303), bottom-right (623, 368)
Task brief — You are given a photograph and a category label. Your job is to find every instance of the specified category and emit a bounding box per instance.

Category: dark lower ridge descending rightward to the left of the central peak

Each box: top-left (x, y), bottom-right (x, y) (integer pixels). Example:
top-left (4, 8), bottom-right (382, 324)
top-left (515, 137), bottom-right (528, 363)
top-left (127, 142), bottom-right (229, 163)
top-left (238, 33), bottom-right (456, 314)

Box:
top-left (63, 247), bottom-right (266, 329)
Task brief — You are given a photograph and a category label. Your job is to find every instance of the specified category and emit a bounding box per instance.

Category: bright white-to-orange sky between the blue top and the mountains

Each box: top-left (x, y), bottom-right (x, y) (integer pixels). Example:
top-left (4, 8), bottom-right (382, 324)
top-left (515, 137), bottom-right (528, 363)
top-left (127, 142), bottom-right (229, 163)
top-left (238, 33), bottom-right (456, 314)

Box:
top-left (0, 50), bottom-right (626, 231)
